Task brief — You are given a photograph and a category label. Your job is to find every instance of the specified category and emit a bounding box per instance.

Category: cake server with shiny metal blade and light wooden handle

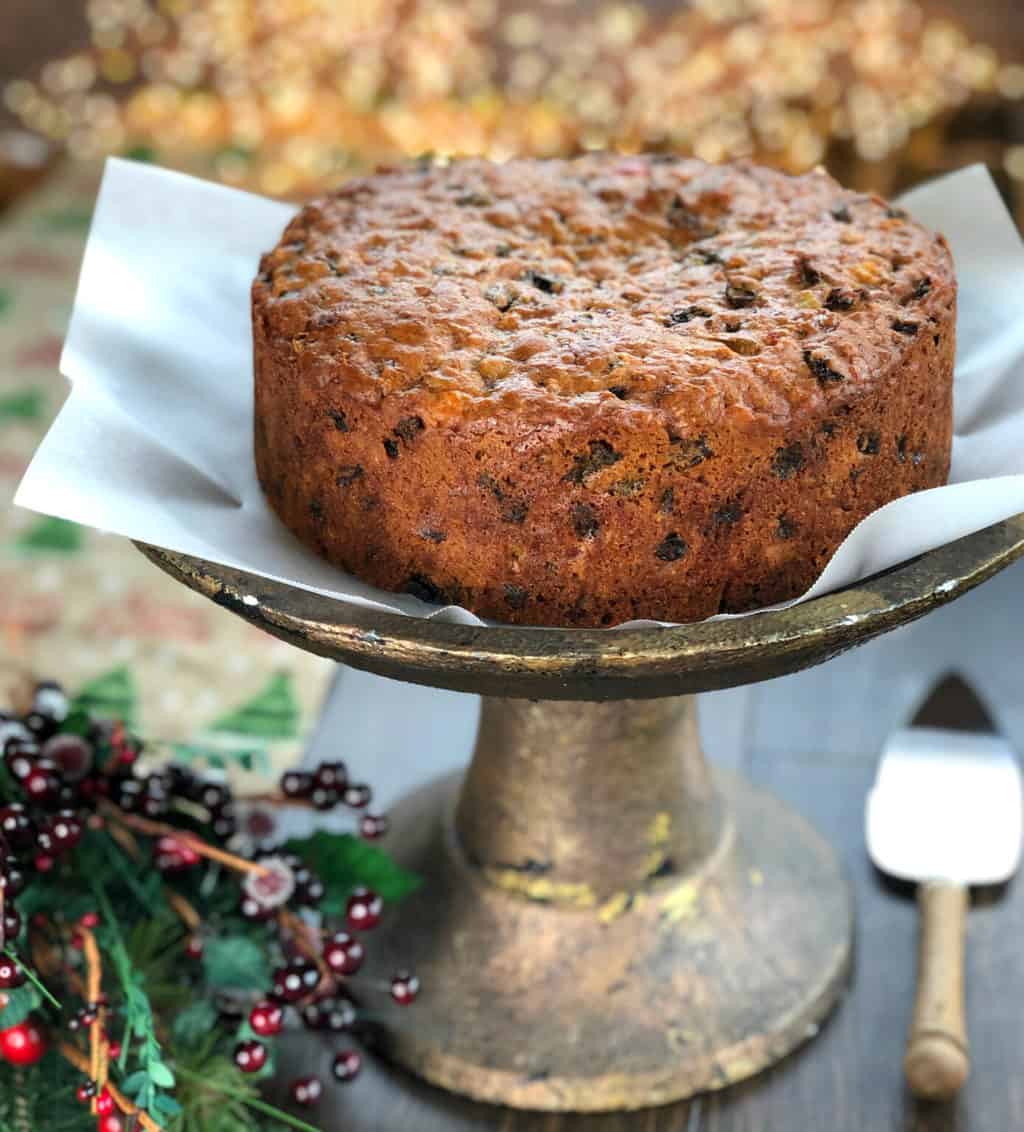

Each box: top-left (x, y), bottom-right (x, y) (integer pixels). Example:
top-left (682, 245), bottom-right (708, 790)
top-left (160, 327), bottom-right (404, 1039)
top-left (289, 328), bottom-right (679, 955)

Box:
top-left (866, 676), bottom-right (1022, 1098)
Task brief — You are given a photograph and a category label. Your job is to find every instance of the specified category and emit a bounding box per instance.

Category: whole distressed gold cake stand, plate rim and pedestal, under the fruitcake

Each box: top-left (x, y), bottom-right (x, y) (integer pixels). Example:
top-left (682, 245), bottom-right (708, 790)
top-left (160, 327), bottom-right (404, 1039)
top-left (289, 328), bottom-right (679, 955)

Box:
top-left (140, 516), bottom-right (1024, 1112)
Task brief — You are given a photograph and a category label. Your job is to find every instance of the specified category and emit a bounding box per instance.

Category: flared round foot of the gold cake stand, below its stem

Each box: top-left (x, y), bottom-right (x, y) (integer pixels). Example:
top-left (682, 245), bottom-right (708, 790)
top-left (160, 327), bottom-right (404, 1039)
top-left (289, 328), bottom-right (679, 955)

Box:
top-left (371, 756), bottom-right (852, 1112)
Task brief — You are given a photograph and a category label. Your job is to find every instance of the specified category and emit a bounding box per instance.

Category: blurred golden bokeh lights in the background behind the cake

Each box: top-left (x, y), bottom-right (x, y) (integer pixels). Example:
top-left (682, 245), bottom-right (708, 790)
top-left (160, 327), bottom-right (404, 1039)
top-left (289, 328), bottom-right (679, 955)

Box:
top-left (0, 0), bottom-right (1024, 218)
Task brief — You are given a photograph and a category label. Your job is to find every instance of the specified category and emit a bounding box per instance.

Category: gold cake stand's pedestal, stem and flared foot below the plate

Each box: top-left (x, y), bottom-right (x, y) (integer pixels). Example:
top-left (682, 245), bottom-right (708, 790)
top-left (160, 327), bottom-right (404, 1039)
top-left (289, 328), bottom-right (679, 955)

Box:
top-left (369, 697), bottom-right (853, 1112)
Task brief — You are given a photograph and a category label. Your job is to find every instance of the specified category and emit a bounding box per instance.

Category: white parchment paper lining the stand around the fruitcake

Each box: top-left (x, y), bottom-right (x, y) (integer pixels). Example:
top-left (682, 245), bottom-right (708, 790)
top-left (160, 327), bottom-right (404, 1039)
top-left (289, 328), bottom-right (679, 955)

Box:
top-left (15, 160), bottom-right (1024, 624)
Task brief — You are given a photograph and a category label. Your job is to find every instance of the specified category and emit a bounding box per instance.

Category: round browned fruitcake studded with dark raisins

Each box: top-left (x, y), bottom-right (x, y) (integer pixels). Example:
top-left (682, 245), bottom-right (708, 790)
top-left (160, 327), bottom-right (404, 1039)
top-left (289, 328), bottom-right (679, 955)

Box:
top-left (252, 154), bottom-right (956, 626)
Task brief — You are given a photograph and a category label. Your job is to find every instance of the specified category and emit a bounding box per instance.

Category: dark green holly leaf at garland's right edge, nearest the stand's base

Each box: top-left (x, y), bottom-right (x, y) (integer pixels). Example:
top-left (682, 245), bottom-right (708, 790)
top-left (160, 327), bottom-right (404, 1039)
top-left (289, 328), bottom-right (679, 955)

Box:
top-left (285, 830), bottom-right (422, 916)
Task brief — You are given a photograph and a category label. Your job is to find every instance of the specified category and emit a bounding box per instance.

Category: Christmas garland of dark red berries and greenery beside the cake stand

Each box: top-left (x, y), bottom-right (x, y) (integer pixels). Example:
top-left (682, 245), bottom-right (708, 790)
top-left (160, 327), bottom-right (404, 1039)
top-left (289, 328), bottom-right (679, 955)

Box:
top-left (0, 681), bottom-right (419, 1132)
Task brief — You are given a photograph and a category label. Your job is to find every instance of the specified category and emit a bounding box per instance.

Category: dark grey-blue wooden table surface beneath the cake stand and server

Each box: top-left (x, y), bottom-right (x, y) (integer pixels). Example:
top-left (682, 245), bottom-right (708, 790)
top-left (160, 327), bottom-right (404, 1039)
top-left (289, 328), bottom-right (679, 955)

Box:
top-left (273, 564), bottom-right (1024, 1132)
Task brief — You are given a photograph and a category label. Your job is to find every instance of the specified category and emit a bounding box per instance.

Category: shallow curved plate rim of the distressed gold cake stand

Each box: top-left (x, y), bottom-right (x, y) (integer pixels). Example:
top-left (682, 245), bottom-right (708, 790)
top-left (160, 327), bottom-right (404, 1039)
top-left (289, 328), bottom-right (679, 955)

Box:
top-left (135, 514), bottom-right (1024, 700)
